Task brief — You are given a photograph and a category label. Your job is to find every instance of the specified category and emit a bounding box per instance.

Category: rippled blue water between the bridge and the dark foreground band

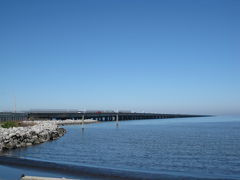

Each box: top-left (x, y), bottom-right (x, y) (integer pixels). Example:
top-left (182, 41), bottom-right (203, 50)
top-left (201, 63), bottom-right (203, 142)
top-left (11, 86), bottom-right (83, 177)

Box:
top-left (4, 117), bottom-right (240, 179)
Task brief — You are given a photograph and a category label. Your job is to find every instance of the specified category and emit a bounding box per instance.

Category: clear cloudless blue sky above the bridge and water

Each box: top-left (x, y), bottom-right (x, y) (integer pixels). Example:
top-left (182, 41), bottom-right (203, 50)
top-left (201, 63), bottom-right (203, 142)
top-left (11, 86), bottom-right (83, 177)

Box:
top-left (0, 0), bottom-right (240, 114)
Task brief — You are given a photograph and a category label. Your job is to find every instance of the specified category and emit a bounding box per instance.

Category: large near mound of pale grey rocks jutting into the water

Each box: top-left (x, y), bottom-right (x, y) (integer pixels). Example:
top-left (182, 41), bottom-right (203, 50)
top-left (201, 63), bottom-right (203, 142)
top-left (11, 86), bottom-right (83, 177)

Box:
top-left (0, 121), bottom-right (66, 151)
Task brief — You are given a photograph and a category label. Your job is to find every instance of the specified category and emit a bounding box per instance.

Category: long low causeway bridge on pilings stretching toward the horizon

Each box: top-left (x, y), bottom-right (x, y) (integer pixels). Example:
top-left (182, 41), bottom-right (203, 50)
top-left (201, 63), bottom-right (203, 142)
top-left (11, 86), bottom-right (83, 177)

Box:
top-left (0, 111), bottom-right (206, 121)
